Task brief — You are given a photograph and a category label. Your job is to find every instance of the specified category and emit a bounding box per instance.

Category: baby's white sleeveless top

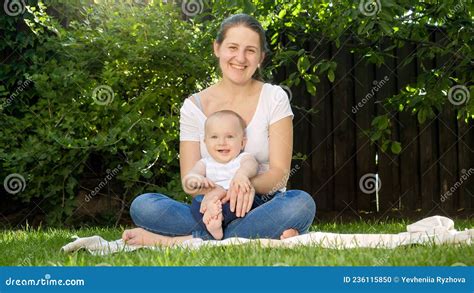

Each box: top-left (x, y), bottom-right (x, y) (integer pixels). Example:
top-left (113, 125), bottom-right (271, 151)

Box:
top-left (200, 152), bottom-right (249, 190)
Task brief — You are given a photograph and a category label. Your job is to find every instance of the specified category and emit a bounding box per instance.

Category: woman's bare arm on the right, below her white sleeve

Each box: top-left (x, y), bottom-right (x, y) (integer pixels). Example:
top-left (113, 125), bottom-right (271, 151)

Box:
top-left (250, 117), bottom-right (293, 194)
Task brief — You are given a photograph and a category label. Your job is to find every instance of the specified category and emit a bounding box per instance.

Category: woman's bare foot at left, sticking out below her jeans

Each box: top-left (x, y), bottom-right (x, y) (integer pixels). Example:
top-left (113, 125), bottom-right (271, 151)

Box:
top-left (122, 228), bottom-right (193, 246)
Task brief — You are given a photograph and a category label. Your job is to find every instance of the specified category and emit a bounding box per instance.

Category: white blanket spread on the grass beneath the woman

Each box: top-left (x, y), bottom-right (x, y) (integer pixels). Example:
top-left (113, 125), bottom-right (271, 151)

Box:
top-left (61, 216), bottom-right (474, 255)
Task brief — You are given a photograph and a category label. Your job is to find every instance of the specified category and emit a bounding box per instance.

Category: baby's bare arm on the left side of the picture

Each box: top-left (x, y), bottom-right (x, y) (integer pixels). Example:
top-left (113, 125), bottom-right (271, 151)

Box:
top-left (182, 160), bottom-right (215, 195)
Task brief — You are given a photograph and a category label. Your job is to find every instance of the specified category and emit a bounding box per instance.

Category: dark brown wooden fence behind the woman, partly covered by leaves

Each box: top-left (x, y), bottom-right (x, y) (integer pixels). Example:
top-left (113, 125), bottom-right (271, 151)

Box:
top-left (277, 33), bottom-right (474, 215)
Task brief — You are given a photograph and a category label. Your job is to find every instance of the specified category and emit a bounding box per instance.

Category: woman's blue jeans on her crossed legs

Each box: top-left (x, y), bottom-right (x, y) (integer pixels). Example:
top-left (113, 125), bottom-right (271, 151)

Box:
top-left (130, 190), bottom-right (316, 240)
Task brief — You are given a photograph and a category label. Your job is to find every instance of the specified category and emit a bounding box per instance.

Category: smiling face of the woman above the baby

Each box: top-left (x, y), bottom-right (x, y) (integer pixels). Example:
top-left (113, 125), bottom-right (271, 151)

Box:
top-left (214, 25), bottom-right (265, 84)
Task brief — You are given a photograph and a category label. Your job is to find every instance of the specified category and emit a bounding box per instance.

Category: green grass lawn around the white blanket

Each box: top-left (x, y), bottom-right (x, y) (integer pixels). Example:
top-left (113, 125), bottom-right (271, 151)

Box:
top-left (0, 219), bottom-right (474, 266)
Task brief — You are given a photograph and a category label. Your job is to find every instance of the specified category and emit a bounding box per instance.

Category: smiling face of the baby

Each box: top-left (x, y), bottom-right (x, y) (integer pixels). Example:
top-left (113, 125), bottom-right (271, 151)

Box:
top-left (204, 115), bottom-right (246, 164)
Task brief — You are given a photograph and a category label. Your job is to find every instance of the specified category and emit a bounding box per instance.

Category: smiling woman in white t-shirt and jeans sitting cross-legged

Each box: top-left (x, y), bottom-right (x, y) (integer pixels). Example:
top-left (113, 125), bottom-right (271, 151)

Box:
top-left (122, 14), bottom-right (316, 245)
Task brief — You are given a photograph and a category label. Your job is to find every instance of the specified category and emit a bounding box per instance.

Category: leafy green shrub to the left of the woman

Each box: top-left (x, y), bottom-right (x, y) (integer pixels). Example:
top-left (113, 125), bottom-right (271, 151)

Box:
top-left (0, 3), bottom-right (213, 224)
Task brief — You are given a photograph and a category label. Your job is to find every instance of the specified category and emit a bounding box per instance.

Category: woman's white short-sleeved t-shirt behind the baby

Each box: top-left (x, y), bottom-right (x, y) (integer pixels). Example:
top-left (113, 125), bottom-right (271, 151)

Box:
top-left (179, 83), bottom-right (293, 174)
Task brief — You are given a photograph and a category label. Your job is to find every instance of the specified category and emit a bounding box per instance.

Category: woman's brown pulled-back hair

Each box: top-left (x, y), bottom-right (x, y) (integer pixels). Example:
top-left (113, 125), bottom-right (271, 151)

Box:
top-left (216, 13), bottom-right (269, 80)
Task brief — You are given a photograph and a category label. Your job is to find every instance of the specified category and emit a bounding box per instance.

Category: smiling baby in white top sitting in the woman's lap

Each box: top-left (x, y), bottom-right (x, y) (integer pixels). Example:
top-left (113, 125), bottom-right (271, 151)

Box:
top-left (183, 110), bottom-right (258, 240)
